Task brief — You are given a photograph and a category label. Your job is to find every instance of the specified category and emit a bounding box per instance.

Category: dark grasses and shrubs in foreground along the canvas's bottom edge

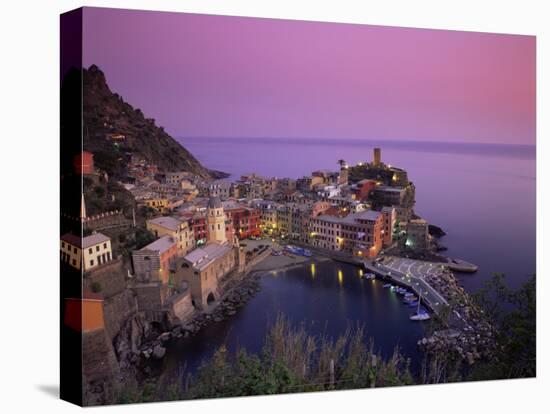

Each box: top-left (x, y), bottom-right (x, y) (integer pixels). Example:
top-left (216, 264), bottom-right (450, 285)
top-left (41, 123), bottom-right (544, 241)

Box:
top-left (105, 274), bottom-right (536, 403)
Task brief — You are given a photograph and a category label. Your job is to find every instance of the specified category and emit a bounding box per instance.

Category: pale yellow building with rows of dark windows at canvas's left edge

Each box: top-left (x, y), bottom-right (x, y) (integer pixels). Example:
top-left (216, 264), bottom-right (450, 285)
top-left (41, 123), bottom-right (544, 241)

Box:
top-left (61, 233), bottom-right (113, 272)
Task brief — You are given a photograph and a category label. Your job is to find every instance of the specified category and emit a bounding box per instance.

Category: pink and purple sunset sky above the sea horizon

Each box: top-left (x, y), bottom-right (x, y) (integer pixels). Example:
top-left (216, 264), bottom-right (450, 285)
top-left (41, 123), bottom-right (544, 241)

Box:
top-left (84, 8), bottom-right (535, 144)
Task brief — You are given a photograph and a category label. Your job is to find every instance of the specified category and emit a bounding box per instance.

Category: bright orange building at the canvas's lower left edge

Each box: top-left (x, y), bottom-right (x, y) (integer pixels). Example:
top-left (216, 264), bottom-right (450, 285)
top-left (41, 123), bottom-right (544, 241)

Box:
top-left (64, 291), bottom-right (105, 332)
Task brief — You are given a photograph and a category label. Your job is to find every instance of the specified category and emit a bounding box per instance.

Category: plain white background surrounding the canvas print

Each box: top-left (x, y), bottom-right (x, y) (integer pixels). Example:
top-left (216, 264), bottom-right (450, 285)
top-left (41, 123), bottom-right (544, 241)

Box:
top-left (0, 0), bottom-right (550, 414)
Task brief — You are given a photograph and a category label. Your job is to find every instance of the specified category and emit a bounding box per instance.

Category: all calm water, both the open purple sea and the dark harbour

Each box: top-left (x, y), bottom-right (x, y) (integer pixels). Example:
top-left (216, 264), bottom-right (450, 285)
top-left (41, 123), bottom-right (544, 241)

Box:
top-left (165, 138), bottom-right (535, 372)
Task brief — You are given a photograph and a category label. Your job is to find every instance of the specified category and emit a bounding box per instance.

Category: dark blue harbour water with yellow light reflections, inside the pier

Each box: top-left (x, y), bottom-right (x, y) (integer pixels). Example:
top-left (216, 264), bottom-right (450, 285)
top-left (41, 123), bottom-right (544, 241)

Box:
top-left (164, 261), bottom-right (425, 375)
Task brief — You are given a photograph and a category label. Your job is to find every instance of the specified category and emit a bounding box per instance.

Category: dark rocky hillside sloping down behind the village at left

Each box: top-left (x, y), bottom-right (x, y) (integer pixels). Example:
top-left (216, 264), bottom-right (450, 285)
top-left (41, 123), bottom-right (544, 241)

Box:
top-left (82, 65), bottom-right (224, 178)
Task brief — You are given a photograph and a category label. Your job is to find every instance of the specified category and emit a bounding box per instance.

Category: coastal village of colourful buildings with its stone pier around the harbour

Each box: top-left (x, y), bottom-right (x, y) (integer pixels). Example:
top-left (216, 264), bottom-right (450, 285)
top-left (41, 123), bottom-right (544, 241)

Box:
top-left (60, 135), bottom-right (492, 398)
